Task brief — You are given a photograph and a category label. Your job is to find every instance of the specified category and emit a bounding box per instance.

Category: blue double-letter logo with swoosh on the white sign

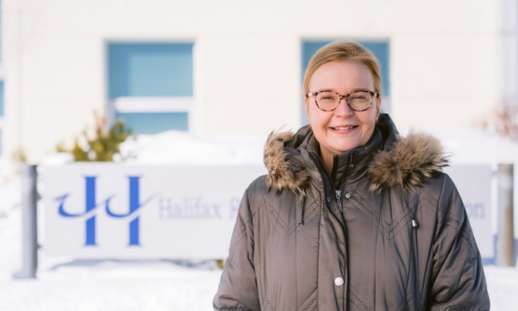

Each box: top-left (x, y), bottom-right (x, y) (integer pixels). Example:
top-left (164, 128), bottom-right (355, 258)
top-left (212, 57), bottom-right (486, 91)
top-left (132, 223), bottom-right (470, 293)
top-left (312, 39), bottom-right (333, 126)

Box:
top-left (56, 176), bottom-right (149, 246)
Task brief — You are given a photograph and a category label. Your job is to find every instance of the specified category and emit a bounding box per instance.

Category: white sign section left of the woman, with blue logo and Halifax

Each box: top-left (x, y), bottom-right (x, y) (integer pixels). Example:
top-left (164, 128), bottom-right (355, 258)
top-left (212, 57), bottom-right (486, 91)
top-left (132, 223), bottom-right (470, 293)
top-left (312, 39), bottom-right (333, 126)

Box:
top-left (40, 164), bottom-right (265, 259)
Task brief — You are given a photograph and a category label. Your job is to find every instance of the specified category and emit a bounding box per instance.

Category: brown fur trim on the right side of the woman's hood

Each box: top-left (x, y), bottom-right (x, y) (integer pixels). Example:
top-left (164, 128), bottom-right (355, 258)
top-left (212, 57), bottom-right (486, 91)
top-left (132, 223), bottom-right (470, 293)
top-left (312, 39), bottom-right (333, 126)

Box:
top-left (369, 134), bottom-right (448, 191)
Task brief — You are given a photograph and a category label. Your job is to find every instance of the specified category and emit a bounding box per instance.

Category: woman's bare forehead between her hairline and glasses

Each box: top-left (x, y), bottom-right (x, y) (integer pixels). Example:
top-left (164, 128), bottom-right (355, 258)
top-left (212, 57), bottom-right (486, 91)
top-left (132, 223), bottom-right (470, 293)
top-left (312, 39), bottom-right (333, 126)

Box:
top-left (309, 61), bottom-right (374, 92)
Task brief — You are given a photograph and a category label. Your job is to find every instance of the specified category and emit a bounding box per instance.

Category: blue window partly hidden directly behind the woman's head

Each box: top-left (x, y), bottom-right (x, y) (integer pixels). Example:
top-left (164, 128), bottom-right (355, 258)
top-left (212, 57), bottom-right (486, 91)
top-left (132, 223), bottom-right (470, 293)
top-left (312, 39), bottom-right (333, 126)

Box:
top-left (302, 40), bottom-right (390, 123)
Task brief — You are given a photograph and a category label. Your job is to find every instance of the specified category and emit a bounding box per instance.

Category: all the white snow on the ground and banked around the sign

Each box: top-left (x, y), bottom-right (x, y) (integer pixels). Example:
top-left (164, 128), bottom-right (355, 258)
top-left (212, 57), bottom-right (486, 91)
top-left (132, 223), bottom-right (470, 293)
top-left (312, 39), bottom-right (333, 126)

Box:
top-left (0, 131), bottom-right (518, 311)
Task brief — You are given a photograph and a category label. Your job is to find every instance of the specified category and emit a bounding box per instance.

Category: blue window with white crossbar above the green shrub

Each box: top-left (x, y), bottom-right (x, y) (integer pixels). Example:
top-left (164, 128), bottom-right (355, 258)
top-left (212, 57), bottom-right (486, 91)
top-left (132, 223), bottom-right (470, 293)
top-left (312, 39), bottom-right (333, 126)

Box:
top-left (108, 42), bottom-right (193, 134)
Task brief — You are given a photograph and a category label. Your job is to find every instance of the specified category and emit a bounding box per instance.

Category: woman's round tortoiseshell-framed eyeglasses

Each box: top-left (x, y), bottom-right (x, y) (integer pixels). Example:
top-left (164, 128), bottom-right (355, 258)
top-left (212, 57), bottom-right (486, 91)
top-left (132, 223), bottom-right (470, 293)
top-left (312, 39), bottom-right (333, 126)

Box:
top-left (306, 90), bottom-right (378, 112)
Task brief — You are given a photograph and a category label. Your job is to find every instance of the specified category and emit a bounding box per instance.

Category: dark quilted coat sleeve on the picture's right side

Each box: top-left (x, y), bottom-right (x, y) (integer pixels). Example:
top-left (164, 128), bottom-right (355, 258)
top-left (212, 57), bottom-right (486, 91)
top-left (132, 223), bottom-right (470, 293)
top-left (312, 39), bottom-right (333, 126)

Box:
top-left (430, 175), bottom-right (490, 310)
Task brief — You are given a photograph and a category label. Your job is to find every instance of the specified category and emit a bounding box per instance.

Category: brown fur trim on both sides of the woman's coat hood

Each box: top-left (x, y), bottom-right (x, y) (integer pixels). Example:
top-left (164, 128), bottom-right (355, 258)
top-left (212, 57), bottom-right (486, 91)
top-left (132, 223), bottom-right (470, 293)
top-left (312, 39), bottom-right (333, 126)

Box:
top-left (264, 114), bottom-right (448, 193)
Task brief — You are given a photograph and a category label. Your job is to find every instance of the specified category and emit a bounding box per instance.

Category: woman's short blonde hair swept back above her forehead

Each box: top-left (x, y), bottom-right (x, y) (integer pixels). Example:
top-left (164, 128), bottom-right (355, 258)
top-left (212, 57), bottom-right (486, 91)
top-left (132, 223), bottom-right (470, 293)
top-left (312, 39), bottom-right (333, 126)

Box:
top-left (303, 41), bottom-right (381, 98)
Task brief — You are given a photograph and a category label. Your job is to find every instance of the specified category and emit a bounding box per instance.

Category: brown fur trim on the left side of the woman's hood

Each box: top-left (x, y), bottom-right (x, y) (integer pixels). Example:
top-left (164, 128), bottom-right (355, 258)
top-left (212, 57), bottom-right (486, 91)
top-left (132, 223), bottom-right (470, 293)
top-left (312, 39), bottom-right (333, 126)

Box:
top-left (263, 132), bottom-right (309, 194)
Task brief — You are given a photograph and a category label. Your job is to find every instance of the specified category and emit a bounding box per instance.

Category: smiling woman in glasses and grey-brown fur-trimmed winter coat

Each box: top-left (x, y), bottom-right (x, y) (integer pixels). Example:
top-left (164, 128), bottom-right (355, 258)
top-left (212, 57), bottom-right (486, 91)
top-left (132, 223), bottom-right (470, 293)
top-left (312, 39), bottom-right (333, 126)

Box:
top-left (214, 42), bottom-right (489, 311)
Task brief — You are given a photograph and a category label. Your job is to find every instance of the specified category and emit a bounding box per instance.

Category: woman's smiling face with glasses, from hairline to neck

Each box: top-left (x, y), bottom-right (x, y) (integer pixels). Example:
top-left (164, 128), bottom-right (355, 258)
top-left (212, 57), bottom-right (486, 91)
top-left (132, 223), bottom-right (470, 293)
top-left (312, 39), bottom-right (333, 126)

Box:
top-left (305, 61), bottom-right (381, 172)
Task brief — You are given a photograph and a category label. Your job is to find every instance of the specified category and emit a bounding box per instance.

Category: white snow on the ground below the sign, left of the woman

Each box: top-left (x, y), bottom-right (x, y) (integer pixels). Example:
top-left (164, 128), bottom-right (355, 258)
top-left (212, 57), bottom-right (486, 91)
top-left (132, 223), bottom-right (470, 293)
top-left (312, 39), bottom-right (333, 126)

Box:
top-left (0, 261), bottom-right (221, 311)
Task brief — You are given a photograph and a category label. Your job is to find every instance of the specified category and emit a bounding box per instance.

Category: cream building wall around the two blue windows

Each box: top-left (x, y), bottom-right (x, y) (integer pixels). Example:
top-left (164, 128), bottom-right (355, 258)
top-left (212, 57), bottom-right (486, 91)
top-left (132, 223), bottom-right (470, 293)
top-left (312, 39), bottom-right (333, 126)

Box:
top-left (3, 0), bottom-right (508, 160)
